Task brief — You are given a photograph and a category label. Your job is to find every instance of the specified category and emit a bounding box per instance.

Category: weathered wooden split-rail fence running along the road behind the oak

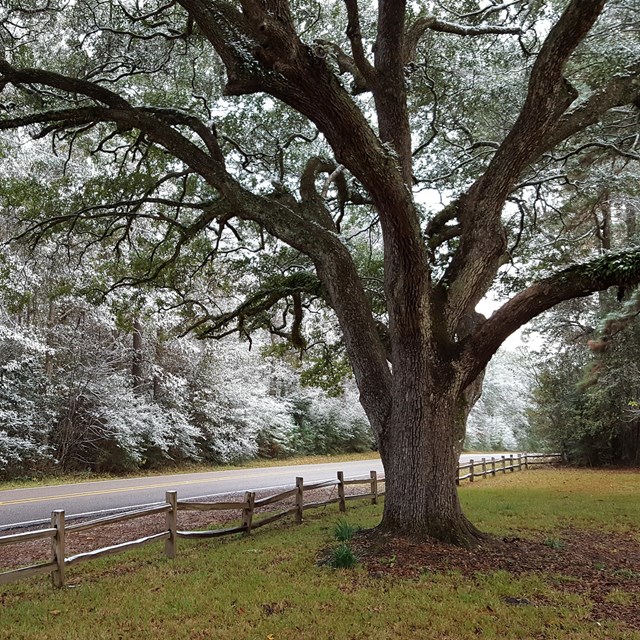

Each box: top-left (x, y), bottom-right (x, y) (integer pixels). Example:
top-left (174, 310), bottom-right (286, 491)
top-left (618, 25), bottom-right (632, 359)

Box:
top-left (0, 454), bottom-right (561, 587)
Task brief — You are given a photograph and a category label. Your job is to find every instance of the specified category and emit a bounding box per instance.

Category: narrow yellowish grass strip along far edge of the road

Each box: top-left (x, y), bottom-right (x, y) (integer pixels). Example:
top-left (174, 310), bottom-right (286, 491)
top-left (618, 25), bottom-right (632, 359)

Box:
top-left (0, 451), bottom-right (380, 491)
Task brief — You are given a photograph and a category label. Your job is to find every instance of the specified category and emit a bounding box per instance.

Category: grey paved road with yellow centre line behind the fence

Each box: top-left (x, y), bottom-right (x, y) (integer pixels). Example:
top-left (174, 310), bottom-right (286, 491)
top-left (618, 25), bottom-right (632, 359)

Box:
top-left (0, 455), bottom-right (479, 530)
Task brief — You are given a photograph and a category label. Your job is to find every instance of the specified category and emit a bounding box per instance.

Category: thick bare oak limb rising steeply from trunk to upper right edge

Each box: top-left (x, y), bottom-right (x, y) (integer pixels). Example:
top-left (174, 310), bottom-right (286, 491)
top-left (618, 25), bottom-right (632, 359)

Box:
top-left (445, 0), bottom-right (605, 333)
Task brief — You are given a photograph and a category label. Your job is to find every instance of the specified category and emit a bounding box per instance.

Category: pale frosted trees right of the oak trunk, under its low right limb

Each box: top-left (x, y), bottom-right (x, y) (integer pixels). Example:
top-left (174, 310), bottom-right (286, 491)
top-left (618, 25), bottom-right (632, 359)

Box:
top-left (465, 350), bottom-right (532, 451)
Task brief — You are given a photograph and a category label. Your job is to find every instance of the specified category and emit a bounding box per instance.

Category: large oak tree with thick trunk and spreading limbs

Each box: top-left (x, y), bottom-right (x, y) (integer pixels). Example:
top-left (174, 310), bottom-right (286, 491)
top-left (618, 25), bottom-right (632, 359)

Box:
top-left (0, 0), bottom-right (640, 544)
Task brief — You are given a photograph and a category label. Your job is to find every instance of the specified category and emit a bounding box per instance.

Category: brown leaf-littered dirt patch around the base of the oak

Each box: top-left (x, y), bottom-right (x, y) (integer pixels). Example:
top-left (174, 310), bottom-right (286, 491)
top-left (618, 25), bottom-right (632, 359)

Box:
top-left (352, 529), bottom-right (640, 630)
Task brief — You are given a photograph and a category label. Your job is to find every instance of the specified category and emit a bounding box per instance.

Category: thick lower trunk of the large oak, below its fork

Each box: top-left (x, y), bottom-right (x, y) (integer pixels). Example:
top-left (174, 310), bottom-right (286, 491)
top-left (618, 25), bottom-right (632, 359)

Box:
top-left (380, 377), bottom-right (484, 547)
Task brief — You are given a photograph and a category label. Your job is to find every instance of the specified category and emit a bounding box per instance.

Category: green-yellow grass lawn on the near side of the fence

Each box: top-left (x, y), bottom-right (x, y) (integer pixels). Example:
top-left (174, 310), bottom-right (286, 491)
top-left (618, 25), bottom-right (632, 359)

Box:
top-left (0, 470), bottom-right (640, 640)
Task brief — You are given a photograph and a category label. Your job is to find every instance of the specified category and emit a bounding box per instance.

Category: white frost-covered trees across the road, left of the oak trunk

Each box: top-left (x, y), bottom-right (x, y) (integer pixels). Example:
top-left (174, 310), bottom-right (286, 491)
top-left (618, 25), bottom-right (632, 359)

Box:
top-left (0, 240), bottom-right (373, 477)
